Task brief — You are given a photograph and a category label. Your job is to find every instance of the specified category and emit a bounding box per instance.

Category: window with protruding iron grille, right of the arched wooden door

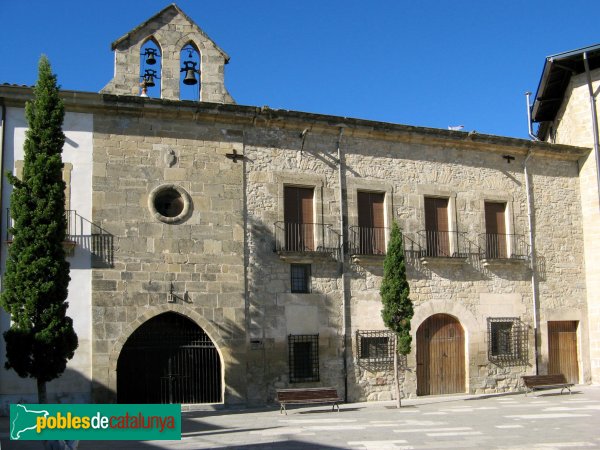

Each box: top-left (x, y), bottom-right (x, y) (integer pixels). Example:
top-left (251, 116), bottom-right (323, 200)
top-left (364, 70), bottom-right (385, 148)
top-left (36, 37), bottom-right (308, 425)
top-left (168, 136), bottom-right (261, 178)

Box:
top-left (488, 317), bottom-right (527, 363)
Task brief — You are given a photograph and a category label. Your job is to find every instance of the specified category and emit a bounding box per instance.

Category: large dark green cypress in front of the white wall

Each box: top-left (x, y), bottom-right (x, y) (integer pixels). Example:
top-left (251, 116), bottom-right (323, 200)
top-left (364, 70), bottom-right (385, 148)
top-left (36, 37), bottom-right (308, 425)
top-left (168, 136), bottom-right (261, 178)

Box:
top-left (1, 56), bottom-right (77, 403)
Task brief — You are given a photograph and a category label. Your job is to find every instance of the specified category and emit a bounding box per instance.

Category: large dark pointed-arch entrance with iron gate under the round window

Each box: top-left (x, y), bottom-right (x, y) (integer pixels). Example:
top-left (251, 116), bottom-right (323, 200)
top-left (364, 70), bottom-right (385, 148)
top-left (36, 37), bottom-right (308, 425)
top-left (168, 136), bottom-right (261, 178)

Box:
top-left (117, 312), bottom-right (222, 403)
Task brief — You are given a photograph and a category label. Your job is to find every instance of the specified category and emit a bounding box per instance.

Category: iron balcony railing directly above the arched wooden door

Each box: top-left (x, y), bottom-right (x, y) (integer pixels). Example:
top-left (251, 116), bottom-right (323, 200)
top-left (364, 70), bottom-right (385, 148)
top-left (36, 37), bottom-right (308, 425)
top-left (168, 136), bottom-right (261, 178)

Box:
top-left (417, 230), bottom-right (480, 258)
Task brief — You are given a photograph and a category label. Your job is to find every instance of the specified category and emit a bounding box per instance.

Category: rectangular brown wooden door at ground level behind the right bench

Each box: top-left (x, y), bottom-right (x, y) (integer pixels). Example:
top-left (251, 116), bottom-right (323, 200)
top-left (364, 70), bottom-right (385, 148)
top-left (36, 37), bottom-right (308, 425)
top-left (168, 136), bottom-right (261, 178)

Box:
top-left (548, 320), bottom-right (579, 384)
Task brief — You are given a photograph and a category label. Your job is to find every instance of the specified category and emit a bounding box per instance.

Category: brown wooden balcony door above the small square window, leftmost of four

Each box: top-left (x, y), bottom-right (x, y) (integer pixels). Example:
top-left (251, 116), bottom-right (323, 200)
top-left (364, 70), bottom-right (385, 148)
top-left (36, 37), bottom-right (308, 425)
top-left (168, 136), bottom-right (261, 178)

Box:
top-left (284, 186), bottom-right (315, 252)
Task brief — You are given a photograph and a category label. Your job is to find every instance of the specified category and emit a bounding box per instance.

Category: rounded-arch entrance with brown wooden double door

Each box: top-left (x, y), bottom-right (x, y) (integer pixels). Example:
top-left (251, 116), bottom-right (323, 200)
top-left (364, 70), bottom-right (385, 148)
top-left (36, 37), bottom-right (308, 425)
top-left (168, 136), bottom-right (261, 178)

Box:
top-left (417, 314), bottom-right (465, 395)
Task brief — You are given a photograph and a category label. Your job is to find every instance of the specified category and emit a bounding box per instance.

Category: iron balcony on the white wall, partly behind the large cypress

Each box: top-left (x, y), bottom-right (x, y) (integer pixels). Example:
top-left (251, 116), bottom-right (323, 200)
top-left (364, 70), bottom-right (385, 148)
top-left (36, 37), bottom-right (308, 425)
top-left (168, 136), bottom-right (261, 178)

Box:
top-left (6, 208), bottom-right (113, 267)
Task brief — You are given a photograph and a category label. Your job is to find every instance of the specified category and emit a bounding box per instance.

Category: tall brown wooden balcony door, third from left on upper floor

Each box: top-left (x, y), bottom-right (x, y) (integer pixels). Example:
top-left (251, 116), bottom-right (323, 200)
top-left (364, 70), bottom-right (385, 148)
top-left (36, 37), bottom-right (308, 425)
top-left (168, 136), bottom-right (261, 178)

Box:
top-left (425, 197), bottom-right (452, 256)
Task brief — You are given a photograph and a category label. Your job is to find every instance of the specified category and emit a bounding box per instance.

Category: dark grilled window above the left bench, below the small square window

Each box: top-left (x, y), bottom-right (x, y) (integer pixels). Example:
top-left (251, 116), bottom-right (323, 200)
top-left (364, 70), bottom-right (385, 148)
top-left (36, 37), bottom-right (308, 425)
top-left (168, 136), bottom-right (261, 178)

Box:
top-left (288, 334), bottom-right (319, 383)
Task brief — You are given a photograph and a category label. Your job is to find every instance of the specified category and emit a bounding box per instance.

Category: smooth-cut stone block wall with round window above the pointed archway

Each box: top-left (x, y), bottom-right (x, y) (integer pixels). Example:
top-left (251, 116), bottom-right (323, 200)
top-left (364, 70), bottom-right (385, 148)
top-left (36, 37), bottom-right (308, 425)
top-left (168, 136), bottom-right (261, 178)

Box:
top-left (92, 106), bottom-right (246, 403)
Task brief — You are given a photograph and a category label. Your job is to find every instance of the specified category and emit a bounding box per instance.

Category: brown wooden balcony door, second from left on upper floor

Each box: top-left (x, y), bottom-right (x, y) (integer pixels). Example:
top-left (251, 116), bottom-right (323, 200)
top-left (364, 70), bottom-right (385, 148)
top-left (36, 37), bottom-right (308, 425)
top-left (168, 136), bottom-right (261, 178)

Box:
top-left (357, 192), bottom-right (385, 255)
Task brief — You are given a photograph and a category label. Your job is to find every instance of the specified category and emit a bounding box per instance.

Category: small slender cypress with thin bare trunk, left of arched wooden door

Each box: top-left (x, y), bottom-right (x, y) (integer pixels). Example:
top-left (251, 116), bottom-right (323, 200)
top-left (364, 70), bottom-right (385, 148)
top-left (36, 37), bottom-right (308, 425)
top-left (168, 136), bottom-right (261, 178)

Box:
top-left (379, 222), bottom-right (414, 407)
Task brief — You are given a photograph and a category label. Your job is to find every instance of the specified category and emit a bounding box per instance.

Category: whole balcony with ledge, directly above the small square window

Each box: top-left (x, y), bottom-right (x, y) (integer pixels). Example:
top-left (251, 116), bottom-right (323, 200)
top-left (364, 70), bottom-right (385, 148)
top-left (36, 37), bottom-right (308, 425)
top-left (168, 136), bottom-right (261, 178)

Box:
top-left (274, 222), bottom-right (340, 262)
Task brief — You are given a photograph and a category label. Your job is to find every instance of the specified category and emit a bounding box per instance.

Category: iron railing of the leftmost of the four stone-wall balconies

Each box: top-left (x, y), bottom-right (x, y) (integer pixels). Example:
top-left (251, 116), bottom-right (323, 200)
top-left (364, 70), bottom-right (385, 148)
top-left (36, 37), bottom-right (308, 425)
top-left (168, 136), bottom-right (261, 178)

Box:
top-left (274, 222), bottom-right (340, 254)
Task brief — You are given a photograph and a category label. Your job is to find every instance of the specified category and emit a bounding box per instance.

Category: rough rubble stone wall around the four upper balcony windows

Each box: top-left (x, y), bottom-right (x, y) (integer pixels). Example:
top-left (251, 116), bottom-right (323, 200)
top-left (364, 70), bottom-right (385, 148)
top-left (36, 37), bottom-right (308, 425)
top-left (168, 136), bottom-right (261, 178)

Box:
top-left (245, 128), bottom-right (588, 401)
